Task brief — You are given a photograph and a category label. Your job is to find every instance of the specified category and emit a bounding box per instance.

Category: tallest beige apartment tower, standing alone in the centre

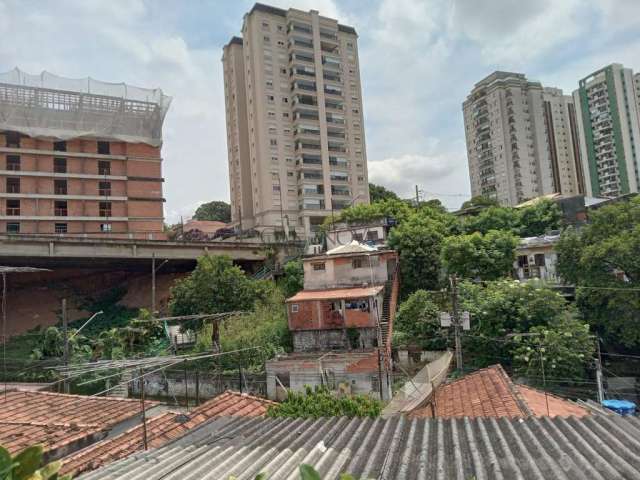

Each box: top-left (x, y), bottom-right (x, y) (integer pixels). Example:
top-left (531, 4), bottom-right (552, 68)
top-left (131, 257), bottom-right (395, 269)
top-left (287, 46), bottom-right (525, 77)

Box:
top-left (222, 3), bottom-right (369, 236)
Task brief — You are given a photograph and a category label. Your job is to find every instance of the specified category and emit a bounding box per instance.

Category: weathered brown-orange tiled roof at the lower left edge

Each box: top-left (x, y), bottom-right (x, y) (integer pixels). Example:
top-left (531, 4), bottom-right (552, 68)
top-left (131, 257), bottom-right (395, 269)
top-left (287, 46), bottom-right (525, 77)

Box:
top-left (0, 391), bottom-right (156, 453)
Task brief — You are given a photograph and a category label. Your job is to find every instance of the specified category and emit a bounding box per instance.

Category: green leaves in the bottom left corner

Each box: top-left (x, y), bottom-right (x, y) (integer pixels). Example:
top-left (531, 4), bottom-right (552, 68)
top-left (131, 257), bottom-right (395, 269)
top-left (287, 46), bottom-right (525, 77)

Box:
top-left (0, 445), bottom-right (71, 480)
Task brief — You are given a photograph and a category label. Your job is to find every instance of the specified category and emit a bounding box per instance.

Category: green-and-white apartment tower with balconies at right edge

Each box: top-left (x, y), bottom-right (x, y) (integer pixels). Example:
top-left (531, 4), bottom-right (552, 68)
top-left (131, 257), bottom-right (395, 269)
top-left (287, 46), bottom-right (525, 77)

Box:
top-left (573, 63), bottom-right (640, 197)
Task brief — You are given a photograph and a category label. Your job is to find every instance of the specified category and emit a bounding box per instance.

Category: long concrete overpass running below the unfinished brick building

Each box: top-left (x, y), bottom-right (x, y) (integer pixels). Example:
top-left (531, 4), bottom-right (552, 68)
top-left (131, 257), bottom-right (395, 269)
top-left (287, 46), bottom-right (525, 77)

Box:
top-left (0, 235), bottom-right (269, 271)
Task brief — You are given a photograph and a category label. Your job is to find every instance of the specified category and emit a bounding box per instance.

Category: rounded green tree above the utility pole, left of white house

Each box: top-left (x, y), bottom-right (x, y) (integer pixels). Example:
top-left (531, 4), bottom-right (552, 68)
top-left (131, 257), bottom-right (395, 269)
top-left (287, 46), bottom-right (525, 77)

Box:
top-left (442, 230), bottom-right (518, 280)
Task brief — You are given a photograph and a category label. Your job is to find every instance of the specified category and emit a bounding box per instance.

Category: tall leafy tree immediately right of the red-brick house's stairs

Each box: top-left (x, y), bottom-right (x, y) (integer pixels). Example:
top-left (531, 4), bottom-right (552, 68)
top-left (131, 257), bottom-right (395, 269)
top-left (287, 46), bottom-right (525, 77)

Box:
top-left (389, 215), bottom-right (446, 297)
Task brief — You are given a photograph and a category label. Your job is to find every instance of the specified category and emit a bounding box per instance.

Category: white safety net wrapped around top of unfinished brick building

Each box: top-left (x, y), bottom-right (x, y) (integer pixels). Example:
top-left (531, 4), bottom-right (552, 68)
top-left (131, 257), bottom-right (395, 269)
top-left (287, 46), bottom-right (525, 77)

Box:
top-left (0, 68), bottom-right (171, 147)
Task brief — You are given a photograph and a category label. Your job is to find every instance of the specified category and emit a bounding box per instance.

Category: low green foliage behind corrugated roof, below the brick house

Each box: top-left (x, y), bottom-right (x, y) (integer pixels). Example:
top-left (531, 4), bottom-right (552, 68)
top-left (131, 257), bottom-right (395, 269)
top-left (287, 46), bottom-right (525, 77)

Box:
top-left (267, 386), bottom-right (382, 418)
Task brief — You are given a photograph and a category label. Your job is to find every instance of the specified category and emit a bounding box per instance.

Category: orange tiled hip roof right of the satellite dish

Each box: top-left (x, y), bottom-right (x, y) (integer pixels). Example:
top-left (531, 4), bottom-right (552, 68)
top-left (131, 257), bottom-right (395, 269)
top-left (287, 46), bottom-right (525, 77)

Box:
top-left (411, 365), bottom-right (588, 418)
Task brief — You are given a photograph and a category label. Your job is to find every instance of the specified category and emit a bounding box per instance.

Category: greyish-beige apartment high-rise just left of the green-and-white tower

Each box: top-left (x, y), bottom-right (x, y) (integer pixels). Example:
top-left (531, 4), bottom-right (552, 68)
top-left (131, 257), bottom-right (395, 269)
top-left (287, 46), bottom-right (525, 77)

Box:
top-left (462, 71), bottom-right (580, 206)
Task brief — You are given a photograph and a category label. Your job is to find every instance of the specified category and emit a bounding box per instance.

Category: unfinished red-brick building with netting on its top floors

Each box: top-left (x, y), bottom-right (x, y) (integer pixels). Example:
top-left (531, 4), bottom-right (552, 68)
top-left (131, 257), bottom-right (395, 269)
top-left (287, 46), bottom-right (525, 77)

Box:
top-left (0, 69), bottom-right (171, 239)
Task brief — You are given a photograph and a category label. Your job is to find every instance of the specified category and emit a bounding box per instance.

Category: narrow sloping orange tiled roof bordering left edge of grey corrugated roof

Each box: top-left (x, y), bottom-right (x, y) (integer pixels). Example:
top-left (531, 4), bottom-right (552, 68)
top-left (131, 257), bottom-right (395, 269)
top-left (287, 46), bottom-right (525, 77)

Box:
top-left (61, 392), bottom-right (274, 475)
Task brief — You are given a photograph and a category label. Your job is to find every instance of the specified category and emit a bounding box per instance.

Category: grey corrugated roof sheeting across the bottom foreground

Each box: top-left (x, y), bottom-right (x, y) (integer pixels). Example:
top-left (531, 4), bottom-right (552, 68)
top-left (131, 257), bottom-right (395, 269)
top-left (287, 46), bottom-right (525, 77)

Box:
top-left (80, 416), bottom-right (640, 480)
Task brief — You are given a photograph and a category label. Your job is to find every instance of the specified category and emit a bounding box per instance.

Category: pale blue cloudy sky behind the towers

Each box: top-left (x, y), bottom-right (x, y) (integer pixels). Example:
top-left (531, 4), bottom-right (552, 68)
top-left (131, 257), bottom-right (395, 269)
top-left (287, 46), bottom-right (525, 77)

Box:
top-left (0, 0), bottom-right (640, 219)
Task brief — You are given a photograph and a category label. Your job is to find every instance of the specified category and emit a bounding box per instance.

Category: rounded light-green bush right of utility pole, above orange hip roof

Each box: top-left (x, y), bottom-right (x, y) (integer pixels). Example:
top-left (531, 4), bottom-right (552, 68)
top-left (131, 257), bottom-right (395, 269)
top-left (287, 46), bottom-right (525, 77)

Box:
top-left (513, 315), bottom-right (595, 384)
